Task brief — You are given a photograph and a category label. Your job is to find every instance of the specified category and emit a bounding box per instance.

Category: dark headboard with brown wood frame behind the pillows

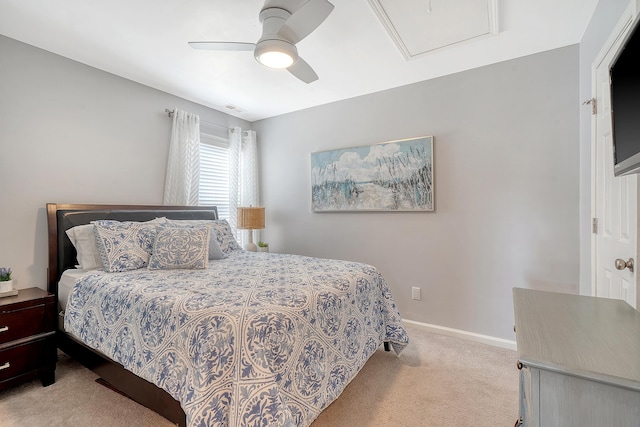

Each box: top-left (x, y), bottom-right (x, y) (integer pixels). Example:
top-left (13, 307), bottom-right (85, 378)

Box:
top-left (47, 203), bottom-right (218, 296)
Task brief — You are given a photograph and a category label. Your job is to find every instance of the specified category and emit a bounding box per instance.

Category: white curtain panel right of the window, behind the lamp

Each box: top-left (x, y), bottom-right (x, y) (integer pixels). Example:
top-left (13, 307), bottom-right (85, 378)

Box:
top-left (229, 127), bottom-right (260, 246)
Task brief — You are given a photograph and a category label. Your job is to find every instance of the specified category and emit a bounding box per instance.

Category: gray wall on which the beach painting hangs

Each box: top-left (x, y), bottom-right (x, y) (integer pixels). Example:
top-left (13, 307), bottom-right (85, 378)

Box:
top-left (253, 45), bottom-right (579, 339)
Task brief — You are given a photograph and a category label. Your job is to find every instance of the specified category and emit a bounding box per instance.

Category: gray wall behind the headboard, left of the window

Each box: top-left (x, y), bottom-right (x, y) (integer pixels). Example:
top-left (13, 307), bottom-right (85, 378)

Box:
top-left (0, 36), bottom-right (249, 289)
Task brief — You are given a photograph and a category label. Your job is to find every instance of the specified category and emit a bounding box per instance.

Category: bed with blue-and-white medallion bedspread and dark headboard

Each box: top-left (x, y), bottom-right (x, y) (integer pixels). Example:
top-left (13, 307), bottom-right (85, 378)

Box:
top-left (47, 203), bottom-right (408, 427)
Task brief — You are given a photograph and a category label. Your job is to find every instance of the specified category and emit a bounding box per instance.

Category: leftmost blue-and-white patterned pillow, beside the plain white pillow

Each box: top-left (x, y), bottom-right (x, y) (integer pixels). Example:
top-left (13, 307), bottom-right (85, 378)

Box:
top-left (93, 220), bottom-right (156, 273)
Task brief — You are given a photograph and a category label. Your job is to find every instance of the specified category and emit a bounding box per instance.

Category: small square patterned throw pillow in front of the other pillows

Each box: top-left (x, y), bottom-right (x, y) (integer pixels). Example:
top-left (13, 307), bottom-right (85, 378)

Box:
top-left (149, 226), bottom-right (210, 270)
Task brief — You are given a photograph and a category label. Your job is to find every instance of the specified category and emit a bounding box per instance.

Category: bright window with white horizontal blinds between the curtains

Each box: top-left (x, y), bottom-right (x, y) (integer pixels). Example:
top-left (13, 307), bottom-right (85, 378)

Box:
top-left (198, 133), bottom-right (229, 220)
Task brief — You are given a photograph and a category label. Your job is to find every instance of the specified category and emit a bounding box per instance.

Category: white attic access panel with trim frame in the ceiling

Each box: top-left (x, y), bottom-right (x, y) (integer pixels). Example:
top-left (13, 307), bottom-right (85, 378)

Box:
top-left (369, 0), bottom-right (498, 60)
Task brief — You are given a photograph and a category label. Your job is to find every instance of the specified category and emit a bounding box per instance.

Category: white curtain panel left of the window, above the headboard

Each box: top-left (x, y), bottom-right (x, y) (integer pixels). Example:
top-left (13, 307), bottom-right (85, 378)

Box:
top-left (163, 108), bottom-right (200, 206)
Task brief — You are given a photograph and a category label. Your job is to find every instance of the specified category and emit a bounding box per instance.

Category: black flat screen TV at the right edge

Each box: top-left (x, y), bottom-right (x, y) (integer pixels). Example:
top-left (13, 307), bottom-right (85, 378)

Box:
top-left (609, 17), bottom-right (640, 176)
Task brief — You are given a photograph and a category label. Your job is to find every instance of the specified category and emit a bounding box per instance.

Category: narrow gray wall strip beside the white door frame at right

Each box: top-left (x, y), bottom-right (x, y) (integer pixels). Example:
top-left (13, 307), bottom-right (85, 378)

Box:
top-left (580, 0), bottom-right (640, 295)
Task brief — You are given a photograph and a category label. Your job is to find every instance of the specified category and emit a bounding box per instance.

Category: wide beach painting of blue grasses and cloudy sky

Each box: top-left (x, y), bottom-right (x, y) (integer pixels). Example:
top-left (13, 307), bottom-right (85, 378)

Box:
top-left (311, 136), bottom-right (435, 212)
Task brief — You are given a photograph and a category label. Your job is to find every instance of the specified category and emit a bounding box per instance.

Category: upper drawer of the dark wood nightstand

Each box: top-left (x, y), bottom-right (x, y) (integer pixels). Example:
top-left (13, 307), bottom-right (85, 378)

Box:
top-left (0, 304), bottom-right (51, 344)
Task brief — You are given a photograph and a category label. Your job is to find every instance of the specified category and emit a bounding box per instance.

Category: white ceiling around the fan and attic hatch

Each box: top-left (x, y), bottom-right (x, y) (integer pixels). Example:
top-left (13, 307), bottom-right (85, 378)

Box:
top-left (0, 0), bottom-right (598, 121)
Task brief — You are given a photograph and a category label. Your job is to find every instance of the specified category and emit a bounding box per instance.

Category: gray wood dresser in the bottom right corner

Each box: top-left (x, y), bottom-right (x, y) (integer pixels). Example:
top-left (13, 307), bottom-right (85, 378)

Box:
top-left (513, 288), bottom-right (640, 427)
